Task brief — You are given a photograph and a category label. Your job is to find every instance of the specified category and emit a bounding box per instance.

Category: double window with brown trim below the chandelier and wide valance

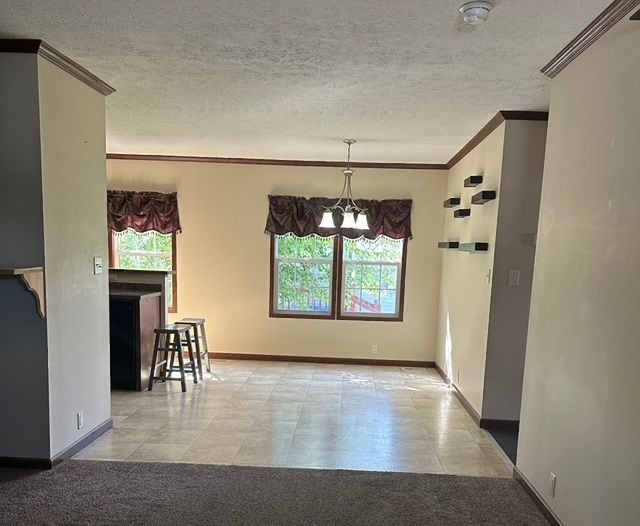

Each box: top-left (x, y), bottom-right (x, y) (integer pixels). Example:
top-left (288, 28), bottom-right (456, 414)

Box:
top-left (270, 234), bottom-right (406, 321)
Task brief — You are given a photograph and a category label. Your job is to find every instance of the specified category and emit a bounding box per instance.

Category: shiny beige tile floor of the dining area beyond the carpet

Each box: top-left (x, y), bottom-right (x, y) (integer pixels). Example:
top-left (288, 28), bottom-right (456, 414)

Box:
top-left (75, 360), bottom-right (511, 477)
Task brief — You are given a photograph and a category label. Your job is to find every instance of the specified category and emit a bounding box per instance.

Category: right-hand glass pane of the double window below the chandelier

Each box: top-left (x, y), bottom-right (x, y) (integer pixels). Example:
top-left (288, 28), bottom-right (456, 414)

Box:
top-left (340, 236), bottom-right (404, 318)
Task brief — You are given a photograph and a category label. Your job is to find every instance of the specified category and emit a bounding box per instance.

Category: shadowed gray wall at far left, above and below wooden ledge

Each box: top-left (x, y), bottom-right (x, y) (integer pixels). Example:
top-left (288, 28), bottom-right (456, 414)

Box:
top-left (0, 53), bottom-right (50, 458)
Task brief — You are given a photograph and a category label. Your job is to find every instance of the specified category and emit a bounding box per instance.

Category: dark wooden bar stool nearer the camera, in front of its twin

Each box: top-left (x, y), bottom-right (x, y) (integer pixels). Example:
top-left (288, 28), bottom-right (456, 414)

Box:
top-left (149, 324), bottom-right (198, 393)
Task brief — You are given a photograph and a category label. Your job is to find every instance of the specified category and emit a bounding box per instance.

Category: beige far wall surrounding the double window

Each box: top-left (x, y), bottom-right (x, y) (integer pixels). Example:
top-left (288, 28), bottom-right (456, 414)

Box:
top-left (107, 160), bottom-right (446, 360)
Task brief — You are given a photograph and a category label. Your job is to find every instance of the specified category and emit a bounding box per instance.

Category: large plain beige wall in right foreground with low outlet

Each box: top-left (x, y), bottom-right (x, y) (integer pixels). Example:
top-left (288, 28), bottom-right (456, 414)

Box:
top-left (518, 15), bottom-right (640, 526)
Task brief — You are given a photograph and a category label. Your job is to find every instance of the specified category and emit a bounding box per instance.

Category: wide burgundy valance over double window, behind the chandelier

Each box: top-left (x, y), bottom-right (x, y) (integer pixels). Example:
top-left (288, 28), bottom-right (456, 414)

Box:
top-left (265, 195), bottom-right (412, 239)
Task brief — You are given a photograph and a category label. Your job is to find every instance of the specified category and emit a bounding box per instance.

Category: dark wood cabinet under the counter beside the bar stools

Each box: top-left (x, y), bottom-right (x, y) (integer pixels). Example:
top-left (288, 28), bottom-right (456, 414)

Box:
top-left (109, 290), bottom-right (162, 391)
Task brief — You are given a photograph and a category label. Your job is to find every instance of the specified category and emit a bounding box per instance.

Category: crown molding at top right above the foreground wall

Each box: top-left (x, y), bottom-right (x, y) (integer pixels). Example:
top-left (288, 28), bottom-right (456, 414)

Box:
top-left (540, 0), bottom-right (640, 78)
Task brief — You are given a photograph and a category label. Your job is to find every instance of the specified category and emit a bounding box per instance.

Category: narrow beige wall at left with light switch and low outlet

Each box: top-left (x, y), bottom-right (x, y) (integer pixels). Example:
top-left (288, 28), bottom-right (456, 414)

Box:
top-left (38, 58), bottom-right (111, 456)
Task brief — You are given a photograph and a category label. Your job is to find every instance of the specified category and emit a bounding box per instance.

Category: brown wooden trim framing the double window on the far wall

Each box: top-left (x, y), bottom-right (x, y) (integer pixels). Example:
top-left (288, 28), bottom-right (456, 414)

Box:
top-left (269, 233), bottom-right (408, 322)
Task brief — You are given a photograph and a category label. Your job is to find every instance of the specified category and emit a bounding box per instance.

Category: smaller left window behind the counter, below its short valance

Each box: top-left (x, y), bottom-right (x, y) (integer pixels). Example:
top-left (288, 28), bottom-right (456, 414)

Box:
top-left (109, 228), bottom-right (178, 312)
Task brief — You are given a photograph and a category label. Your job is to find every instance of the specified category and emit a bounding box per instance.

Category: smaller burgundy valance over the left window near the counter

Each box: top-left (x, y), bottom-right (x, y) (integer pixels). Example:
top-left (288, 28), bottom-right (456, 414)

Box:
top-left (107, 190), bottom-right (182, 234)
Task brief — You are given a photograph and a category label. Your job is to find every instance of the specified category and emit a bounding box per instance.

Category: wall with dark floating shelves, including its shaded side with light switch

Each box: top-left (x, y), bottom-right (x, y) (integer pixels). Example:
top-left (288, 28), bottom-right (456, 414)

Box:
top-left (436, 121), bottom-right (547, 420)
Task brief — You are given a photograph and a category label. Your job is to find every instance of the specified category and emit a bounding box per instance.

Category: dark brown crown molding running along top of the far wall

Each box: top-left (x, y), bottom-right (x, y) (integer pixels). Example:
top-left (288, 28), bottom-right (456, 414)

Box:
top-left (107, 153), bottom-right (447, 170)
